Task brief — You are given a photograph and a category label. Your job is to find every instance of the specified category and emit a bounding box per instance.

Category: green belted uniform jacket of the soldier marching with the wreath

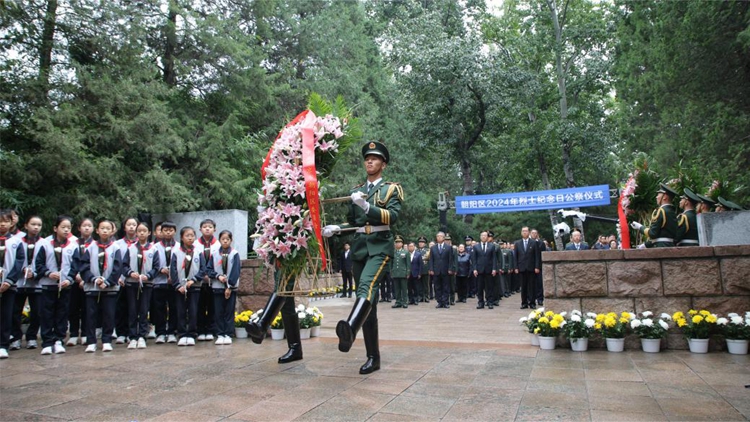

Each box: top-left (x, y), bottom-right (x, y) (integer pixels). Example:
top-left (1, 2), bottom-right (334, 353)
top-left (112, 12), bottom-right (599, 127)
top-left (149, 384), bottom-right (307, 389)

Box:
top-left (342, 179), bottom-right (404, 261)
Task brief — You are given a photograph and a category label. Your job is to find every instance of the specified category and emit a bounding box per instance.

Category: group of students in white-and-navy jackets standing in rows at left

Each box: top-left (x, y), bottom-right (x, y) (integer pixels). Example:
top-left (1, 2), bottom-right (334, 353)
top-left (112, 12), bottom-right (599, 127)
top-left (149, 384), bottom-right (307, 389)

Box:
top-left (0, 210), bottom-right (241, 359)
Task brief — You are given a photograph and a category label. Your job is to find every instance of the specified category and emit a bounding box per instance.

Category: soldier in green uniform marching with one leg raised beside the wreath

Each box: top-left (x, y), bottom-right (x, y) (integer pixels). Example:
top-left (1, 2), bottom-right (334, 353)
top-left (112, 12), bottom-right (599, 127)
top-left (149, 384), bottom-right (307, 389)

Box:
top-left (323, 142), bottom-right (404, 374)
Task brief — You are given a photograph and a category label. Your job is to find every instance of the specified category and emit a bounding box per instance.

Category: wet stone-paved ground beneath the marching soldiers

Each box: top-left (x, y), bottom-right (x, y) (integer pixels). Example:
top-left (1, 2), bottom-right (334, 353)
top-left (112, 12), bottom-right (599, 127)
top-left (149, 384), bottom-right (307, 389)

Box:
top-left (0, 297), bottom-right (750, 421)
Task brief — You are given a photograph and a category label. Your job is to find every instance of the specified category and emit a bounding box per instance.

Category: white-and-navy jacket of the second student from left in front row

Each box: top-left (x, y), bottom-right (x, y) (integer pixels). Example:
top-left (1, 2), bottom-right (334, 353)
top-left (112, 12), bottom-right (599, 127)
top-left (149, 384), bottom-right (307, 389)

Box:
top-left (34, 239), bottom-right (78, 289)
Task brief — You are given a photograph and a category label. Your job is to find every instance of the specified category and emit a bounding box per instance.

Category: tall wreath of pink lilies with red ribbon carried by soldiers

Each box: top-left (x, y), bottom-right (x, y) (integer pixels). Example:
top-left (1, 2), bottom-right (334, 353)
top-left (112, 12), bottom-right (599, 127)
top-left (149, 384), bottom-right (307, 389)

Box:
top-left (252, 94), bottom-right (361, 296)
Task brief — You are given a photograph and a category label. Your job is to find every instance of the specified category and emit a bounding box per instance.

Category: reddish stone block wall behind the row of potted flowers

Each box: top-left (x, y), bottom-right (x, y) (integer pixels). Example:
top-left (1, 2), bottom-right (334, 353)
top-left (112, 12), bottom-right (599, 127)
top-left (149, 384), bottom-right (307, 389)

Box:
top-left (542, 245), bottom-right (750, 349)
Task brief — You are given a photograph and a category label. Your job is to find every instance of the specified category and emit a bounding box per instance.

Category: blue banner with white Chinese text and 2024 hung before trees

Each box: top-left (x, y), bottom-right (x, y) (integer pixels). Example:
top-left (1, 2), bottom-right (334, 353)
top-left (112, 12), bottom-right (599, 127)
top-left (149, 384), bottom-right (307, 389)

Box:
top-left (456, 185), bottom-right (610, 214)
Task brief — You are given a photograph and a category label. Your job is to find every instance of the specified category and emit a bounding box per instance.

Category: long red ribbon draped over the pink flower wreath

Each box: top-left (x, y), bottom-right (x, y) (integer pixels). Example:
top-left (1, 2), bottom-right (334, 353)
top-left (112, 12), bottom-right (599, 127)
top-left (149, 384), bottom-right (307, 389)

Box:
top-left (260, 110), bottom-right (326, 270)
